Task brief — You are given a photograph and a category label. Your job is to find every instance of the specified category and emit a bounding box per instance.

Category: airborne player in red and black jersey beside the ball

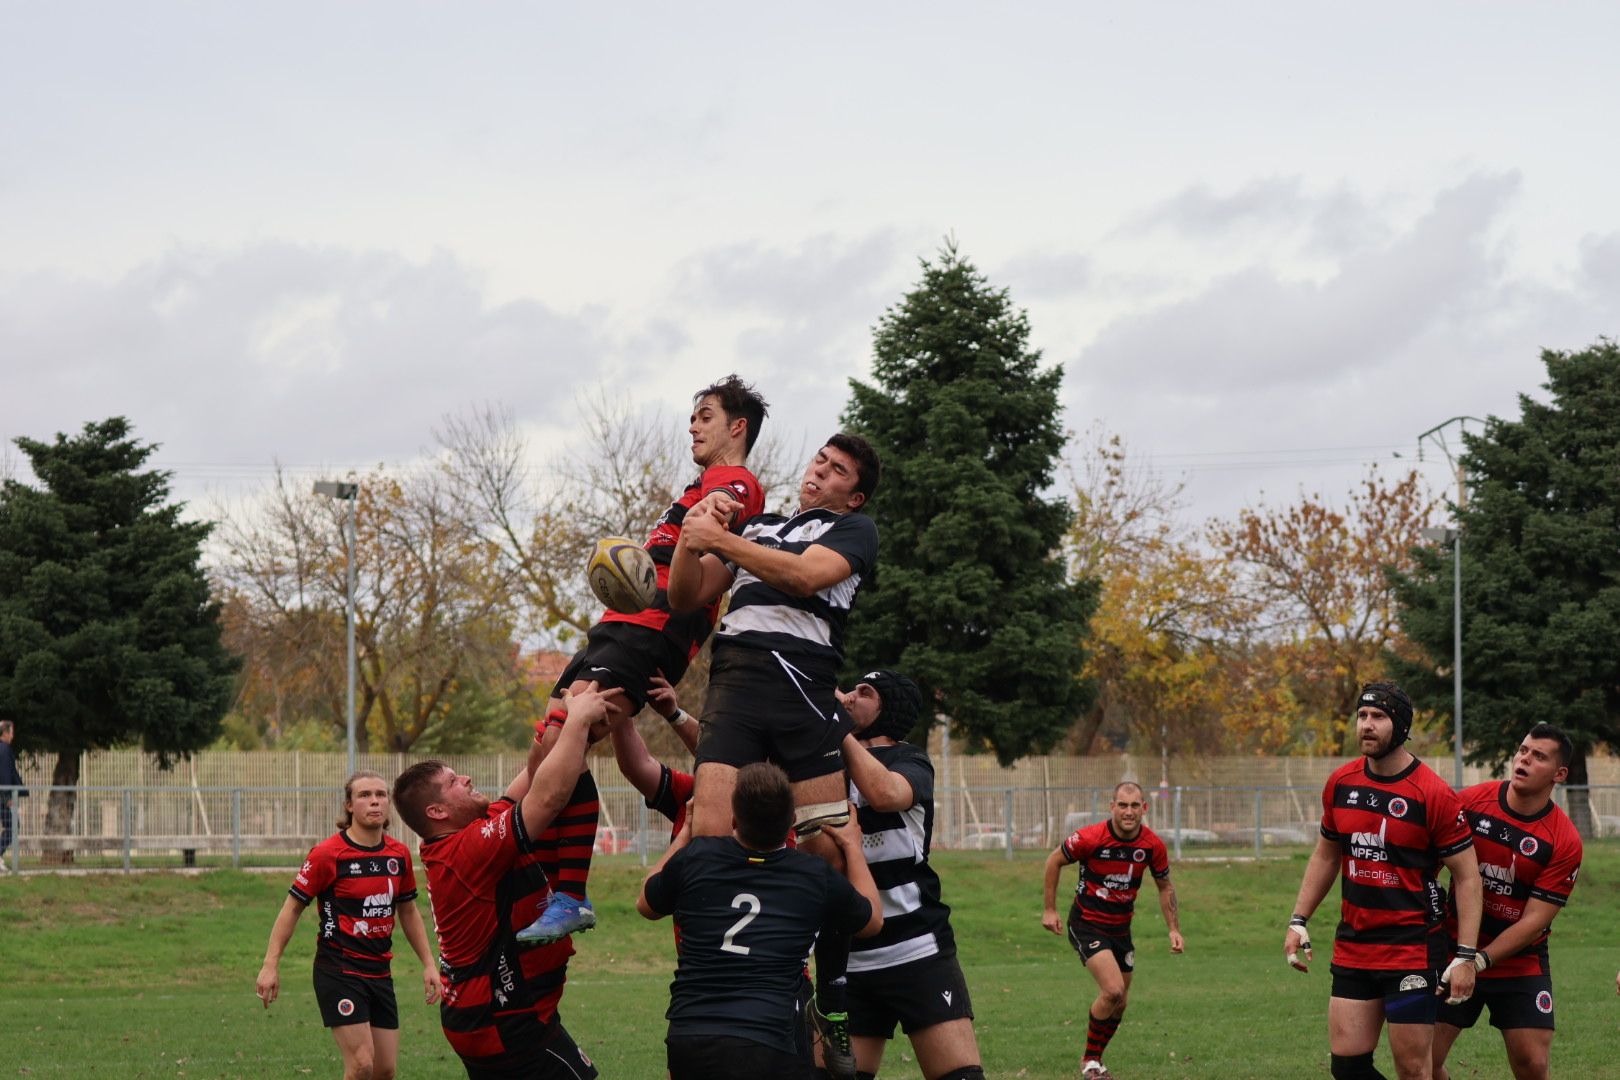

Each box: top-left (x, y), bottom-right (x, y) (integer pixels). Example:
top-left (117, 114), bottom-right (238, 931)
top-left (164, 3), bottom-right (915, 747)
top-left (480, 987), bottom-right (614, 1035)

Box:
top-left (518, 376), bottom-right (768, 944)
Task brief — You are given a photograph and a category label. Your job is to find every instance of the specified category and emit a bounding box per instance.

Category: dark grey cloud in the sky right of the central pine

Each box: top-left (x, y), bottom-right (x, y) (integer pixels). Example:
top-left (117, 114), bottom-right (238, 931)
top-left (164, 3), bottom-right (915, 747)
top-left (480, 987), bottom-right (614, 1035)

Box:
top-left (1064, 173), bottom-right (1620, 518)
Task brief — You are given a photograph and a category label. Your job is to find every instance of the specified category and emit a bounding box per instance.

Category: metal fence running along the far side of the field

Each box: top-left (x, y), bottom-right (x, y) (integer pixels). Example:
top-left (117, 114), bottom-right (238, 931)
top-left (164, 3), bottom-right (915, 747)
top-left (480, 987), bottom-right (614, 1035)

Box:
top-left (12, 784), bottom-right (1620, 870)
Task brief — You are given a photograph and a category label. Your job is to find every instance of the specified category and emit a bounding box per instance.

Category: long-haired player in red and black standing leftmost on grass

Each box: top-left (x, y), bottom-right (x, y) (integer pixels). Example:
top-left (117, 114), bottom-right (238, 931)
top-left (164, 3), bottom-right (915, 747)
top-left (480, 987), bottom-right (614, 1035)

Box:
top-left (258, 771), bottom-right (441, 1080)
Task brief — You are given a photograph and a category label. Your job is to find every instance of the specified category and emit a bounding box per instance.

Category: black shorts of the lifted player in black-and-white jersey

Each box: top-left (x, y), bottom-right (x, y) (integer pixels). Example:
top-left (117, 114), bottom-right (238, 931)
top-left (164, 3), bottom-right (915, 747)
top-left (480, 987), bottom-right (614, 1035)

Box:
top-left (697, 646), bottom-right (852, 780)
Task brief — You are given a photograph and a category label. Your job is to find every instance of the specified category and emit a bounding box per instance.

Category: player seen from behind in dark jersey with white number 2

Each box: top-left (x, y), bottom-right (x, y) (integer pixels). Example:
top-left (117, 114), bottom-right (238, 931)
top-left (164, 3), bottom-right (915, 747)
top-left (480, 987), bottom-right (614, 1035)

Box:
top-left (637, 763), bottom-right (883, 1080)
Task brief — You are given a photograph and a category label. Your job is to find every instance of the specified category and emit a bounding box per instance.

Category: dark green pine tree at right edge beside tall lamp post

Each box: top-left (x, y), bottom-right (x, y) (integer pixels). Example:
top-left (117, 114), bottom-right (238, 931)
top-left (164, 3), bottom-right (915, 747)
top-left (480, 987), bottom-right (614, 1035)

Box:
top-left (1395, 340), bottom-right (1620, 831)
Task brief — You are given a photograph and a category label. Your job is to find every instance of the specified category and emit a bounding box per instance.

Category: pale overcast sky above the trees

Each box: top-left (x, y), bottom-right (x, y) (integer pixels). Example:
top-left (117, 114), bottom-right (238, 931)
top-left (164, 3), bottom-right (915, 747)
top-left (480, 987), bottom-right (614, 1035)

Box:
top-left (0, 0), bottom-right (1620, 531)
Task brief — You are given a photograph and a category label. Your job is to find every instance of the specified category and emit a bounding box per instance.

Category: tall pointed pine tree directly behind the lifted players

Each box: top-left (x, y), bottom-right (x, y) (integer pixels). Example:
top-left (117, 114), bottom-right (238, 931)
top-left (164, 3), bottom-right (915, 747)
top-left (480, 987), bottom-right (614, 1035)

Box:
top-left (844, 243), bottom-right (1097, 763)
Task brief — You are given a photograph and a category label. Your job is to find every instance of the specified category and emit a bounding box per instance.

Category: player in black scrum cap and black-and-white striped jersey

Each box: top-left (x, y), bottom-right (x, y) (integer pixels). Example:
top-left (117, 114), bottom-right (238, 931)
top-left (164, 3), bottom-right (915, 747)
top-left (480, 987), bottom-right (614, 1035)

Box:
top-left (839, 670), bottom-right (985, 1080)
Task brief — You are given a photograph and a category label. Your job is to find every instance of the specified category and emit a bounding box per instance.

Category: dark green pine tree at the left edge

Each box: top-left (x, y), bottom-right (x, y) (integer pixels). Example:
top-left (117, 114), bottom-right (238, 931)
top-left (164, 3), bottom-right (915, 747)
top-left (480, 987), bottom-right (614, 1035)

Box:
top-left (0, 418), bottom-right (237, 854)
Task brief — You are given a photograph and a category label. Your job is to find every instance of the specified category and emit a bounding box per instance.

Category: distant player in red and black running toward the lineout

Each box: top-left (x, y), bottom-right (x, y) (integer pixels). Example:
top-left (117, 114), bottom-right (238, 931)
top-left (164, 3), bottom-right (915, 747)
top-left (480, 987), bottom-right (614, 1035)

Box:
top-left (1040, 780), bottom-right (1186, 1080)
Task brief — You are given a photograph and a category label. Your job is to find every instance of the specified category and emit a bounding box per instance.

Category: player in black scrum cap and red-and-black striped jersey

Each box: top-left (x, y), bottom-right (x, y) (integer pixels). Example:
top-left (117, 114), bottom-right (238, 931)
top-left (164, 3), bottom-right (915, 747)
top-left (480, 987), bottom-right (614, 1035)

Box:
top-left (1283, 682), bottom-right (1481, 1080)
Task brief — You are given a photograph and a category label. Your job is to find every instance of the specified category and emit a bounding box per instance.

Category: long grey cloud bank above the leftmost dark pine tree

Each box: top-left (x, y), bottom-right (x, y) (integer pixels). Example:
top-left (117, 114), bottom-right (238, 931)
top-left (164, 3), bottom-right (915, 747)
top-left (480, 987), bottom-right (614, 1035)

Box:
top-left (0, 243), bottom-right (609, 482)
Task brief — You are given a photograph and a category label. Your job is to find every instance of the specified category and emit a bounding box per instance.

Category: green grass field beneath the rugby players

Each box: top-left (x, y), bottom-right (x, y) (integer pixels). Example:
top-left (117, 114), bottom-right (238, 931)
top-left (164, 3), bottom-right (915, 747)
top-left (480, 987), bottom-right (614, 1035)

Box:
top-left (0, 844), bottom-right (1620, 1080)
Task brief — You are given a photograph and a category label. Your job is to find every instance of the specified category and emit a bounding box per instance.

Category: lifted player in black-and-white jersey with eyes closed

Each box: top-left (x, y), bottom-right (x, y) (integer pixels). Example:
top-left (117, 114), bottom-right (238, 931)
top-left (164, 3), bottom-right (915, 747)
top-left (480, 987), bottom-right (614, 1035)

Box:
top-left (669, 434), bottom-right (880, 1080)
